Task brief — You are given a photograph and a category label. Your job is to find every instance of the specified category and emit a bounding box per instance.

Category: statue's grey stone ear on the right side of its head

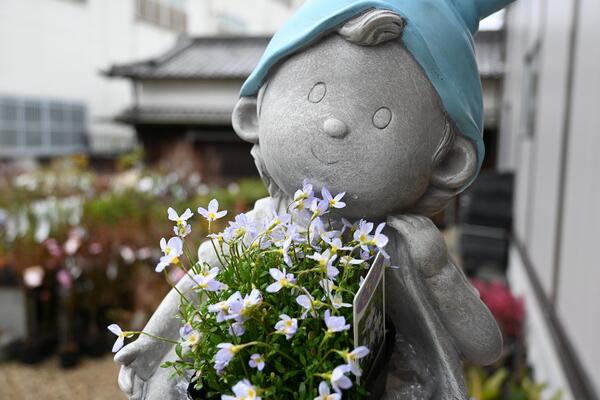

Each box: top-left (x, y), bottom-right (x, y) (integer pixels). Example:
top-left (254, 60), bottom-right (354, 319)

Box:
top-left (431, 135), bottom-right (477, 190)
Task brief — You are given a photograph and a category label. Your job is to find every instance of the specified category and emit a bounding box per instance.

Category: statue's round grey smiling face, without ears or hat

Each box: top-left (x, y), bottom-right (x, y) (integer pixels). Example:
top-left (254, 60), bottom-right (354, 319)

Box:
top-left (259, 34), bottom-right (445, 219)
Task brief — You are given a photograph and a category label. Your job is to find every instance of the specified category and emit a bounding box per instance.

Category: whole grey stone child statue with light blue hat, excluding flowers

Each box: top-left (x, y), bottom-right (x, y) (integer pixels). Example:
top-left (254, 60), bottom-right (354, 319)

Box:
top-left (115, 0), bottom-right (510, 400)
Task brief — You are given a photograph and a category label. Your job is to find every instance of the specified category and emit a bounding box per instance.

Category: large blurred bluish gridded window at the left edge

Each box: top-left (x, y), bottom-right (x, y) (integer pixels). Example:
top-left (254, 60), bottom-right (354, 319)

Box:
top-left (0, 96), bottom-right (87, 157)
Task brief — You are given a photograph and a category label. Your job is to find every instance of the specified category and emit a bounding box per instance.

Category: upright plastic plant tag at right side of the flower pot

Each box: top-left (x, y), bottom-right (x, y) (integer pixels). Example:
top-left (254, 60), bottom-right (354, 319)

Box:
top-left (353, 253), bottom-right (385, 382)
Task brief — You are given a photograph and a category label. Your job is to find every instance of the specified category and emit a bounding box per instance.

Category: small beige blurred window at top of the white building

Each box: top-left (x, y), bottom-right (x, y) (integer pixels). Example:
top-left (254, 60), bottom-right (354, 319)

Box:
top-left (136, 0), bottom-right (187, 33)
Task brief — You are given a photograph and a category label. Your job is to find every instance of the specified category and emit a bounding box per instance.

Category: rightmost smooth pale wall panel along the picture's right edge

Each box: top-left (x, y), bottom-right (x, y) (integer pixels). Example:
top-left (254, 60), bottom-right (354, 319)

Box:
top-left (557, 0), bottom-right (600, 392)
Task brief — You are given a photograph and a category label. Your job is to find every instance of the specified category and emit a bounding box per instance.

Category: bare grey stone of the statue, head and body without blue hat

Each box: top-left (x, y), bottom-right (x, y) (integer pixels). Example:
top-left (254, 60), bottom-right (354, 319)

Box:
top-left (115, 11), bottom-right (502, 400)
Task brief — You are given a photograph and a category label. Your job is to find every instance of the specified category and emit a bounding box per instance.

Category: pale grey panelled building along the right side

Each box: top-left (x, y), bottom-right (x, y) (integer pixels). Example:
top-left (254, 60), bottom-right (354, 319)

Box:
top-left (498, 0), bottom-right (600, 399)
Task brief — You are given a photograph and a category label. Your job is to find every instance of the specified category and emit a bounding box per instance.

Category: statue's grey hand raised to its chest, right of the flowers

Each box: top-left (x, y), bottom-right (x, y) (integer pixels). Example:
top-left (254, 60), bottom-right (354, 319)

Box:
top-left (388, 215), bottom-right (448, 278)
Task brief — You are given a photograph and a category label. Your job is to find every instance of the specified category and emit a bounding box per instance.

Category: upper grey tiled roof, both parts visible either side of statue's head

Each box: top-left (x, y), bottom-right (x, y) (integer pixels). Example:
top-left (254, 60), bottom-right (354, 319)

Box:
top-left (106, 31), bottom-right (504, 80)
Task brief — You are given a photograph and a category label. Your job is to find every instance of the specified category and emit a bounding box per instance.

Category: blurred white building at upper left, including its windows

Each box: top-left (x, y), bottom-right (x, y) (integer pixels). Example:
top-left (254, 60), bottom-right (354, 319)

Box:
top-left (0, 0), bottom-right (294, 158)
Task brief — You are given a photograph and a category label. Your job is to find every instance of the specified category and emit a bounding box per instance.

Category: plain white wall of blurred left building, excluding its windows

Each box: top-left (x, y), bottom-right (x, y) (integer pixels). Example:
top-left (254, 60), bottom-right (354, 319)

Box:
top-left (0, 0), bottom-right (176, 153)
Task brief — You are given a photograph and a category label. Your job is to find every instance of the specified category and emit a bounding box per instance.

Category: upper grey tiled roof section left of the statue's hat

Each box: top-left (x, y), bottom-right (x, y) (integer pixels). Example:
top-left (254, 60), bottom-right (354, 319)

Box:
top-left (106, 37), bottom-right (269, 79)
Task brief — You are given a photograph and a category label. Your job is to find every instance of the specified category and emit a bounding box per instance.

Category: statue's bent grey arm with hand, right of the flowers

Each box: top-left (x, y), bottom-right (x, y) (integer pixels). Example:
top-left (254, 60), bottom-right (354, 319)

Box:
top-left (388, 215), bottom-right (502, 365)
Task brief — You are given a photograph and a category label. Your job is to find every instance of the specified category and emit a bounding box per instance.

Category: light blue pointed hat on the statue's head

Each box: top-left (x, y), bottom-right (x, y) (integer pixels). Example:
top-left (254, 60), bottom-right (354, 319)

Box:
top-left (240, 0), bottom-right (514, 184)
